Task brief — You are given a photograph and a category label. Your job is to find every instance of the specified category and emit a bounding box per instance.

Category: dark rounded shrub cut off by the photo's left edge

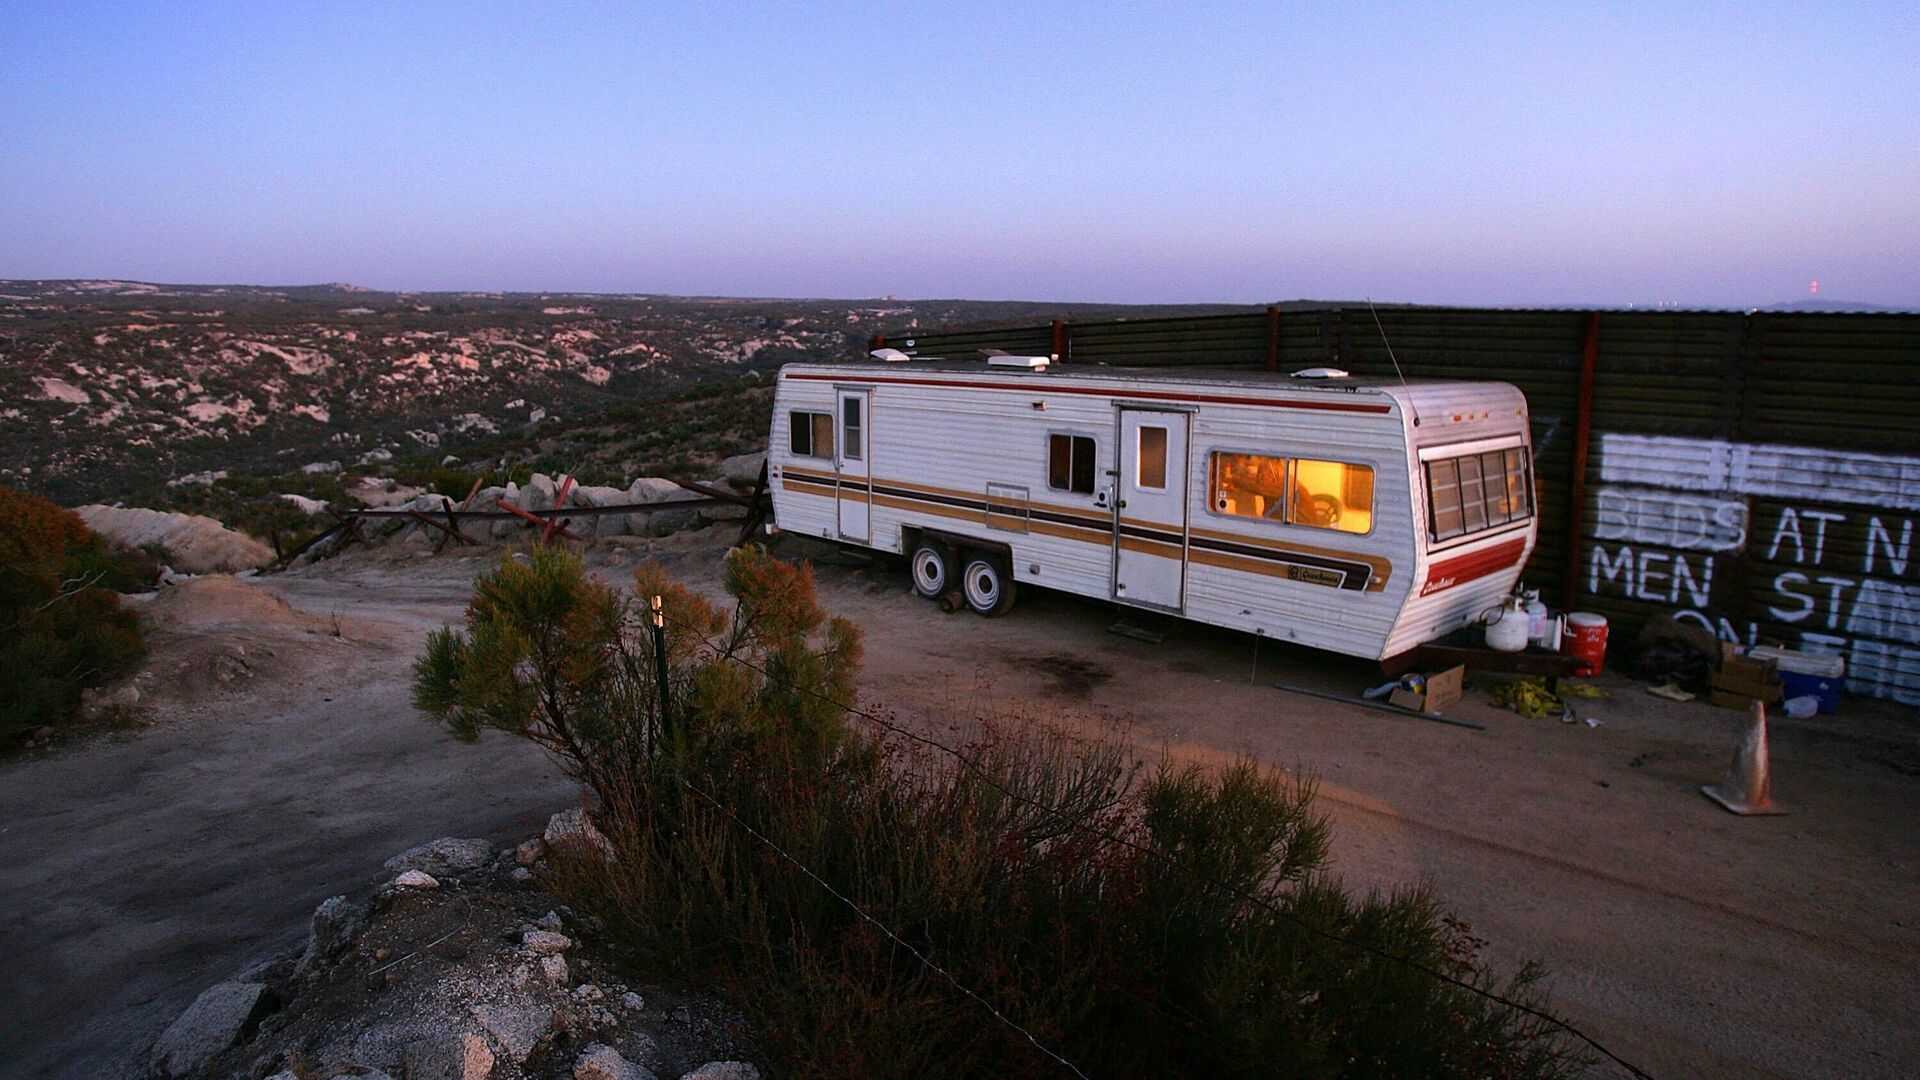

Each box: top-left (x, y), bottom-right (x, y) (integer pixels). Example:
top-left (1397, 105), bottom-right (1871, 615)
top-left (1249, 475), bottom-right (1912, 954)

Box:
top-left (0, 486), bottom-right (146, 748)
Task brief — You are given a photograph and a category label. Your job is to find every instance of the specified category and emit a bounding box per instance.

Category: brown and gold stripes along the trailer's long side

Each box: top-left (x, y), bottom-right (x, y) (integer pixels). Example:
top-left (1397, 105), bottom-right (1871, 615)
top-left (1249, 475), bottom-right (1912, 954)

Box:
top-left (780, 465), bottom-right (1397, 592)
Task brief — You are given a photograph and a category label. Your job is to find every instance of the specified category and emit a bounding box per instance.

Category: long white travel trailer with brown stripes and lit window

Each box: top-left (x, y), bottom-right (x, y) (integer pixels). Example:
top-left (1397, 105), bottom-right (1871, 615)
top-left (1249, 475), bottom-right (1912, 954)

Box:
top-left (768, 354), bottom-right (1536, 659)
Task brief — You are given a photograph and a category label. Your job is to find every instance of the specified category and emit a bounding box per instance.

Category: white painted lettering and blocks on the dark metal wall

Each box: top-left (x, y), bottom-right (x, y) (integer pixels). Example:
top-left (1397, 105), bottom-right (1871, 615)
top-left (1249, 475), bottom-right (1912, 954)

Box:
top-left (1584, 434), bottom-right (1920, 705)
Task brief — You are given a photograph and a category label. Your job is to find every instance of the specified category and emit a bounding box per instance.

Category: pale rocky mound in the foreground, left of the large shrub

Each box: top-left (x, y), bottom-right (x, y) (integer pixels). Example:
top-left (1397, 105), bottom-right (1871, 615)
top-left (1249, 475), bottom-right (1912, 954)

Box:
top-left (165, 834), bottom-right (758, 1080)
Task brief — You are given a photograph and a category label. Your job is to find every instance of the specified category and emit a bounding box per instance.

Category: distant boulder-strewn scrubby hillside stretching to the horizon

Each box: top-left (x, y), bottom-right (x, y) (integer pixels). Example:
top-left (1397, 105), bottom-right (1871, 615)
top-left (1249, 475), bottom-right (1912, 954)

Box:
top-left (0, 281), bottom-right (1244, 503)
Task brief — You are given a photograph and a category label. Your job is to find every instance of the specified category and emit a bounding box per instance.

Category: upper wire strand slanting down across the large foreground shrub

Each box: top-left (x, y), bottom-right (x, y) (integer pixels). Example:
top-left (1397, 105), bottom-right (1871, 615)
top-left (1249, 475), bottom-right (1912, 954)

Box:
top-left (657, 605), bottom-right (1653, 1080)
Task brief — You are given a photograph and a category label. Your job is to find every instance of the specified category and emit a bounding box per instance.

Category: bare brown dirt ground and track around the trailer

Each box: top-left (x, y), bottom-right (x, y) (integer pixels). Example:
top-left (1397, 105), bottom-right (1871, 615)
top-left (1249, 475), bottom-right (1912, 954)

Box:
top-left (0, 530), bottom-right (1920, 1078)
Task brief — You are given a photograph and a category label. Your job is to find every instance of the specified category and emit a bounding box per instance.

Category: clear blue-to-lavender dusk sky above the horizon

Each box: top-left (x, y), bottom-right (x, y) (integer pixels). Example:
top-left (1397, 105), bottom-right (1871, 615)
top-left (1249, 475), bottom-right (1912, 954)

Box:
top-left (0, 0), bottom-right (1920, 307)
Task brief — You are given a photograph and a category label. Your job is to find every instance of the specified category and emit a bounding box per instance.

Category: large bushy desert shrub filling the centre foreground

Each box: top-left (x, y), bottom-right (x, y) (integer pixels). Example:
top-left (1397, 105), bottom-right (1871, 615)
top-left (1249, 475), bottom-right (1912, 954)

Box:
top-left (415, 550), bottom-right (1578, 1078)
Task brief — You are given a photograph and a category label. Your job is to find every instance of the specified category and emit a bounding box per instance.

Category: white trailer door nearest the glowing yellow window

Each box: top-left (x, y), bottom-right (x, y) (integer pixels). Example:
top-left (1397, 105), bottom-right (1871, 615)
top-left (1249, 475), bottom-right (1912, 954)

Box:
top-left (1114, 407), bottom-right (1188, 611)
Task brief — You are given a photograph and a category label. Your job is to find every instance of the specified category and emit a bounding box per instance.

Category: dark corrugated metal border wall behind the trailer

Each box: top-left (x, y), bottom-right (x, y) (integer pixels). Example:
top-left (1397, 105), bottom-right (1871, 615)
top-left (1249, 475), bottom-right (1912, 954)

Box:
top-left (887, 307), bottom-right (1920, 705)
